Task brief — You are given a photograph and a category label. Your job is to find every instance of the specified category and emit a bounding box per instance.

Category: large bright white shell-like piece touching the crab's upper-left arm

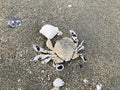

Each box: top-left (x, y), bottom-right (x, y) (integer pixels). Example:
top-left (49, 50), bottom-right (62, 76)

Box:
top-left (39, 24), bottom-right (62, 39)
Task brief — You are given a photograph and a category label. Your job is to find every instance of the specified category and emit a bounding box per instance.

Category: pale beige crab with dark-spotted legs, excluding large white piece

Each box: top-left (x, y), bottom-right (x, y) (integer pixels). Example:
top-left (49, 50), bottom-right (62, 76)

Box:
top-left (33, 30), bottom-right (86, 67)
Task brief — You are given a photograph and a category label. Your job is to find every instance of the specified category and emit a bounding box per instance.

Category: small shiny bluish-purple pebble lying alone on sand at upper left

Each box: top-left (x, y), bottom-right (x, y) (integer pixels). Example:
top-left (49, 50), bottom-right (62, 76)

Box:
top-left (8, 17), bottom-right (22, 28)
